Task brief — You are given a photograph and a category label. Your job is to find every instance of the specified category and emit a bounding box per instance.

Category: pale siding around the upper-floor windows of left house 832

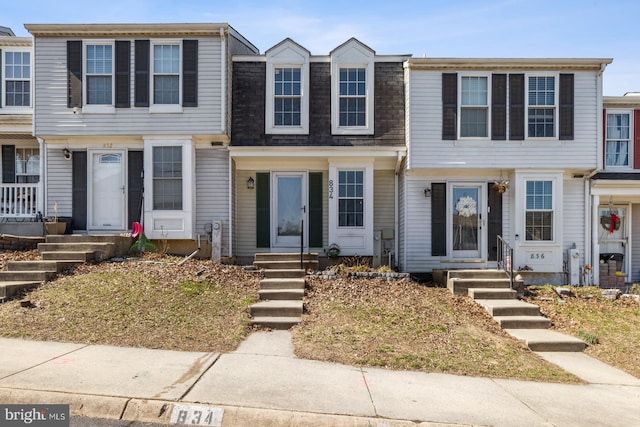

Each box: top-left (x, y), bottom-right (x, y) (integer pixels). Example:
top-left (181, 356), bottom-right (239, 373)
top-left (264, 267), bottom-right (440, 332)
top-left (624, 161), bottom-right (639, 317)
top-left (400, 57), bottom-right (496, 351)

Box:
top-left (34, 37), bottom-right (226, 136)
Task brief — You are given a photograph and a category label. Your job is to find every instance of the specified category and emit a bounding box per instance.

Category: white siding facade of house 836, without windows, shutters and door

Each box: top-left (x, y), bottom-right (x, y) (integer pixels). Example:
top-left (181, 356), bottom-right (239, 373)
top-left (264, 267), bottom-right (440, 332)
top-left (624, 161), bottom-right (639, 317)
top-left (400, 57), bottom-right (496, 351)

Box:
top-left (400, 58), bottom-right (610, 283)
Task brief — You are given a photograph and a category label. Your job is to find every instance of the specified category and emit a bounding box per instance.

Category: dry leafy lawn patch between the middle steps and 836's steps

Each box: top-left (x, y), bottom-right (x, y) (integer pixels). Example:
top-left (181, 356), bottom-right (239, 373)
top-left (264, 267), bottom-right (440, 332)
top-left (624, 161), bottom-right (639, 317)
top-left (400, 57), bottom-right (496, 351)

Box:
top-left (293, 277), bottom-right (577, 382)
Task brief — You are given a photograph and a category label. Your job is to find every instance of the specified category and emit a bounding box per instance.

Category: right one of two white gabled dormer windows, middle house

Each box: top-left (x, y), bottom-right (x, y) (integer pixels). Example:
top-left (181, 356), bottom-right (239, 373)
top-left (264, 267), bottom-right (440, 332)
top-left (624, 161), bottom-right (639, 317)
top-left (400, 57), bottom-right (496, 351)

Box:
top-left (331, 39), bottom-right (375, 135)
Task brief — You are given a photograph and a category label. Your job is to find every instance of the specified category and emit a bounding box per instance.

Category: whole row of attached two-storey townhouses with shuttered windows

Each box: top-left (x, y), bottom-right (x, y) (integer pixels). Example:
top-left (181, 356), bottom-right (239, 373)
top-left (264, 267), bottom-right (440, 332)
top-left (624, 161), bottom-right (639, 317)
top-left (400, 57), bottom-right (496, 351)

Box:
top-left (0, 24), bottom-right (640, 284)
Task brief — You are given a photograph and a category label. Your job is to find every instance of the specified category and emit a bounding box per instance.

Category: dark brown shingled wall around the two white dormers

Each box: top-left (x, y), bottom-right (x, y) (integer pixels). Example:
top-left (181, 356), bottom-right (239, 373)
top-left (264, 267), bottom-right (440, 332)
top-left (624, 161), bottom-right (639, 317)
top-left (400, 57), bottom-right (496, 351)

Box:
top-left (231, 62), bottom-right (405, 146)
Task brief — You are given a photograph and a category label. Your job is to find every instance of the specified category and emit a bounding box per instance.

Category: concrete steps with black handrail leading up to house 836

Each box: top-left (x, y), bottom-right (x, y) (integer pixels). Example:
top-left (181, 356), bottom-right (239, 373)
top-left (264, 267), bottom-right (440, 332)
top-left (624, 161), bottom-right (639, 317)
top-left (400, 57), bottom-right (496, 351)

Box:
top-left (447, 270), bottom-right (586, 352)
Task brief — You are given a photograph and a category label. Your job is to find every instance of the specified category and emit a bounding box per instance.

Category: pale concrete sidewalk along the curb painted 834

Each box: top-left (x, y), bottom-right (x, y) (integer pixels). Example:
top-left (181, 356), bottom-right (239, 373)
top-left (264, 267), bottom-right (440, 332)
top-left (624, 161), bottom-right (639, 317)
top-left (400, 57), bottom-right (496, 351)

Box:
top-left (0, 331), bottom-right (640, 427)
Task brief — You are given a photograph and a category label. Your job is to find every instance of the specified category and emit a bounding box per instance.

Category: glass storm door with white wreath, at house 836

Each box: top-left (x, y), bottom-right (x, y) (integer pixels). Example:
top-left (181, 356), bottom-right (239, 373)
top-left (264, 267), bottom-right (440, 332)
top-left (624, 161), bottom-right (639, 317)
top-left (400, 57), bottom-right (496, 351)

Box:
top-left (451, 185), bottom-right (482, 258)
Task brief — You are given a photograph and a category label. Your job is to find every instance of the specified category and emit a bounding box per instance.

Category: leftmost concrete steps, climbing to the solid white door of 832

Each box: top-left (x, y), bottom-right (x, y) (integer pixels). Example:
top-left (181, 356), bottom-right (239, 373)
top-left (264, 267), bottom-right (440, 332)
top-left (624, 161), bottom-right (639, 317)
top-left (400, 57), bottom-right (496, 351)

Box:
top-left (0, 235), bottom-right (133, 302)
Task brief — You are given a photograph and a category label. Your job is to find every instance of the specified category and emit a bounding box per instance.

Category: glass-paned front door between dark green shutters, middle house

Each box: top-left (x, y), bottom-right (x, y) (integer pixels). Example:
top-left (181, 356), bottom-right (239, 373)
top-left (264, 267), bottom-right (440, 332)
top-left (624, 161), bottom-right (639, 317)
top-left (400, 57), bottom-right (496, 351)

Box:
top-left (271, 172), bottom-right (308, 251)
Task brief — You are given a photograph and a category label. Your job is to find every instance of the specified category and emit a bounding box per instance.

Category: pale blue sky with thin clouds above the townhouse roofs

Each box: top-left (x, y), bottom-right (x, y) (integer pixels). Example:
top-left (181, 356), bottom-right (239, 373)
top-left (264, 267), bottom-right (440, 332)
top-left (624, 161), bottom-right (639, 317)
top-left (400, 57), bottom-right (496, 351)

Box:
top-left (5, 0), bottom-right (640, 96)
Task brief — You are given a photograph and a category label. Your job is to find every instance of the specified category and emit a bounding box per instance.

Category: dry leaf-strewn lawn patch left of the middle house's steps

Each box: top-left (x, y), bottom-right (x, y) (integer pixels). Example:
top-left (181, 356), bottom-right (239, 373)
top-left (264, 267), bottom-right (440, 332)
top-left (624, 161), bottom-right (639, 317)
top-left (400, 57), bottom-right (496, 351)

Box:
top-left (0, 254), bottom-right (259, 351)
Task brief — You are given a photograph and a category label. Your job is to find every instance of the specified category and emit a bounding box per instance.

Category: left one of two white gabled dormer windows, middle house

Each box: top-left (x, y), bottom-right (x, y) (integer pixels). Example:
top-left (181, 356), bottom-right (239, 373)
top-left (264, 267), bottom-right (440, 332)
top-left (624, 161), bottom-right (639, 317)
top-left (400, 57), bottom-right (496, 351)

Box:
top-left (265, 39), bottom-right (309, 135)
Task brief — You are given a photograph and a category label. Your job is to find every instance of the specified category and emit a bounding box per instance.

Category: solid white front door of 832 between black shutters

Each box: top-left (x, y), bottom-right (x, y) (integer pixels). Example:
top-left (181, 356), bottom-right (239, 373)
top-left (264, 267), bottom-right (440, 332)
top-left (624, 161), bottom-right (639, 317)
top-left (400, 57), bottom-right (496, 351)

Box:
top-left (88, 150), bottom-right (126, 230)
